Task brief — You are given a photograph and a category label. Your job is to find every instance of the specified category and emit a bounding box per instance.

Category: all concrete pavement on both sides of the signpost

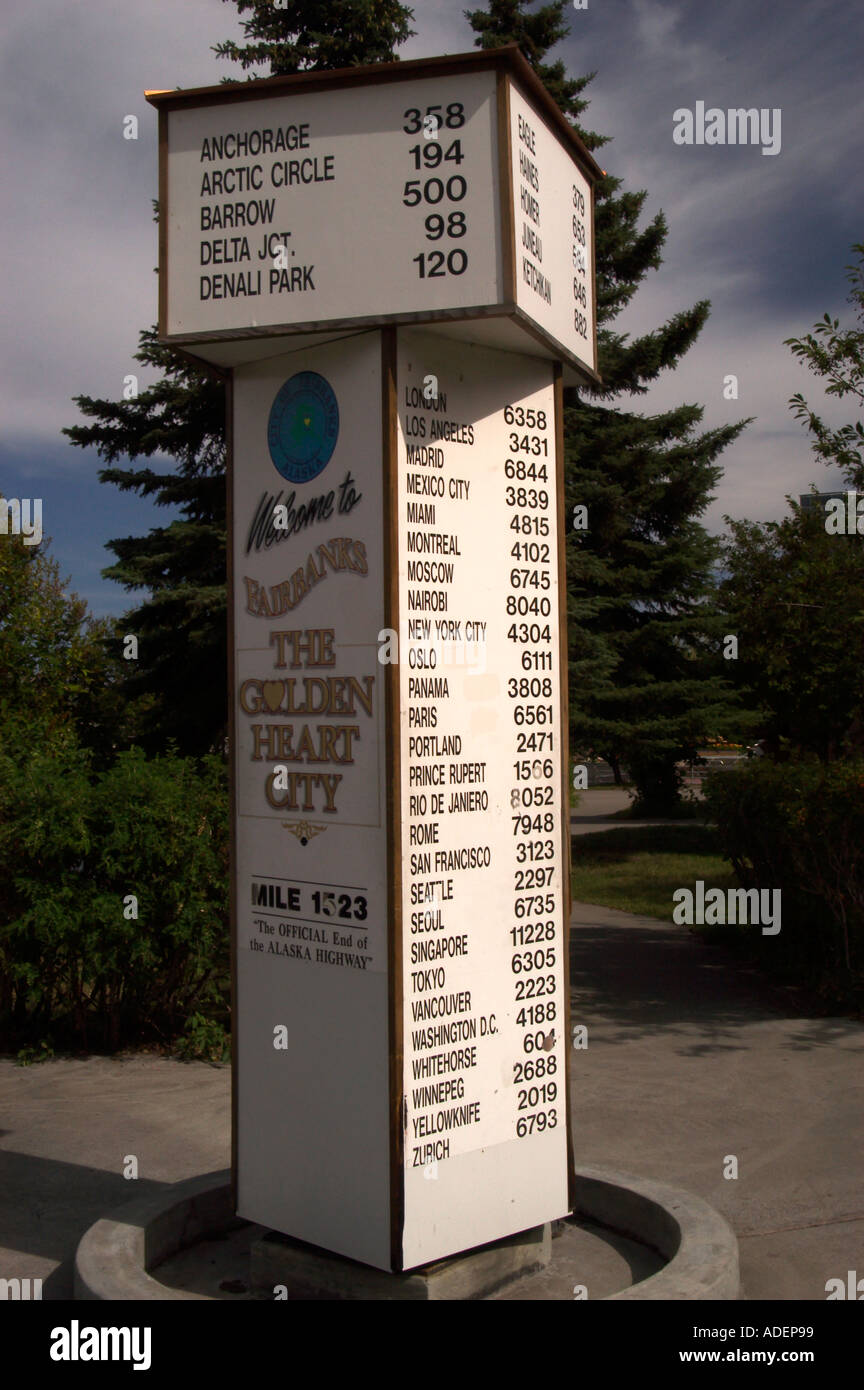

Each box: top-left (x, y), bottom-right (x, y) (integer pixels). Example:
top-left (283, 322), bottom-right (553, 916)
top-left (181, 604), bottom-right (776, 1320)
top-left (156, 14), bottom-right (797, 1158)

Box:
top-left (0, 905), bottom-right (864, 1300)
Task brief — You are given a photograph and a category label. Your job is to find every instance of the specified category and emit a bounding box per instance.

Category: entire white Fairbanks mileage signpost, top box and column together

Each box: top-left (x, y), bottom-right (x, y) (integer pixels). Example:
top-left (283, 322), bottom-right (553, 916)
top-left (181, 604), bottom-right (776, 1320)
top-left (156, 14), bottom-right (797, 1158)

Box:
top-left (149, 47), bottom-right (600, 1270)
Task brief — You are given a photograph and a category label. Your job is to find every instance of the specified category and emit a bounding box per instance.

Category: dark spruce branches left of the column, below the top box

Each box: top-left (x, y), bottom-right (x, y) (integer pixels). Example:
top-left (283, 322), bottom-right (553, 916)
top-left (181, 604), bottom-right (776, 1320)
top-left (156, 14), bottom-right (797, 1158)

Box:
top-left (64, 328), bottom-right (228, 753)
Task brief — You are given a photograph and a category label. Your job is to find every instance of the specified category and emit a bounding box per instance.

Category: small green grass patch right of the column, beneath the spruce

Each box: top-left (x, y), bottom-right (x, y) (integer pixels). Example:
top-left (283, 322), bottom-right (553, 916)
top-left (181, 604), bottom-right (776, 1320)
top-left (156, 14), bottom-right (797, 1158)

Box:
top-left (572, 823), bottom-right (738, 922)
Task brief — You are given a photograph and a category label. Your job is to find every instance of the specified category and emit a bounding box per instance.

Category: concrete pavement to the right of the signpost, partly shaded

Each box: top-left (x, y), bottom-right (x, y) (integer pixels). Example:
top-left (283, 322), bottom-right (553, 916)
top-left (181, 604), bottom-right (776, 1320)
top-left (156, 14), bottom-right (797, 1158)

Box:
top-left (570, 904), bottom-right (864, 1300)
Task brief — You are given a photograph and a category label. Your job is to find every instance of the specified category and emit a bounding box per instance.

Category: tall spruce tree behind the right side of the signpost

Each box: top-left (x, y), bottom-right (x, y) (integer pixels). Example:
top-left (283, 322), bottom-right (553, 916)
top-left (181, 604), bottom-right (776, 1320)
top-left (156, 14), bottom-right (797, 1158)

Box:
top-left (465, 0), bottom-right (747, 813)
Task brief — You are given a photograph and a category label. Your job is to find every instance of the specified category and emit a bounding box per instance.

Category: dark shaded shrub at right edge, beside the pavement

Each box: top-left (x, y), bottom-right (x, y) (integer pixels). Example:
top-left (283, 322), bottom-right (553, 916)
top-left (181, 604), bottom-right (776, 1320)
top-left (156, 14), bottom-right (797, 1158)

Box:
top-left (704, 759), bottom-right (864, 1004)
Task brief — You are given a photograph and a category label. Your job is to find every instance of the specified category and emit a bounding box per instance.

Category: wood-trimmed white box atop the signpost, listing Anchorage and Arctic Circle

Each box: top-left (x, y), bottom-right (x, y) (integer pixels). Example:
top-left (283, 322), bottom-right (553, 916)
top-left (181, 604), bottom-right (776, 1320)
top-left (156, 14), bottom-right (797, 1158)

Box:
top-left (147, 44), bottom-right (603, 384)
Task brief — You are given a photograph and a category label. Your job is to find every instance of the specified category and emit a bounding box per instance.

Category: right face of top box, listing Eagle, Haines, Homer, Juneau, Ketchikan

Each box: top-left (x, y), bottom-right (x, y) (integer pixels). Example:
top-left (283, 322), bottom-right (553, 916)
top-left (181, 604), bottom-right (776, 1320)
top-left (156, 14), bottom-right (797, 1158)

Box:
top-left (510, 86), bottom-right (595, 366)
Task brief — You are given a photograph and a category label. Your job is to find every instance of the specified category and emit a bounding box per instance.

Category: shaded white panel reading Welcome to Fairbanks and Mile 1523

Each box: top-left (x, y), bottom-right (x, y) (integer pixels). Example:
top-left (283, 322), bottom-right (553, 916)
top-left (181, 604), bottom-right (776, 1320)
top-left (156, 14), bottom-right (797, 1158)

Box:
top-left (232, 334), bottom-right (390, 1268)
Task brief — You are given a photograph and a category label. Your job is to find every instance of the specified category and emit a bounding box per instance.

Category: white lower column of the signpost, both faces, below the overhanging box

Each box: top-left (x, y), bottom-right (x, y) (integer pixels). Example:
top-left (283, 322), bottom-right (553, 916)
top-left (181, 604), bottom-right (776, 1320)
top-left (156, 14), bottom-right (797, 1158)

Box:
top-left (232, 331), bottom-right (568, 1269)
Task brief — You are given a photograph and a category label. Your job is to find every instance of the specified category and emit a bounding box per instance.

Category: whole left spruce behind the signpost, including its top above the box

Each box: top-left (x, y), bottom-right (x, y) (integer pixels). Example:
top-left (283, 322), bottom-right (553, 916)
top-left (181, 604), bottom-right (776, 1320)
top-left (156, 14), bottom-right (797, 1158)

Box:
top-left (64, 0), bottom-right (413, 753)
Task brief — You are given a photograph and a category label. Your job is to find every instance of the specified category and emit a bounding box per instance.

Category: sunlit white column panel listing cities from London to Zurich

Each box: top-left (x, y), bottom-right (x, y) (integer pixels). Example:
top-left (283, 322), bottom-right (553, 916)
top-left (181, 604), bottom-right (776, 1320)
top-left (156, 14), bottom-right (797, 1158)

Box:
top-left (397, 331), bottom-right (568, 1266)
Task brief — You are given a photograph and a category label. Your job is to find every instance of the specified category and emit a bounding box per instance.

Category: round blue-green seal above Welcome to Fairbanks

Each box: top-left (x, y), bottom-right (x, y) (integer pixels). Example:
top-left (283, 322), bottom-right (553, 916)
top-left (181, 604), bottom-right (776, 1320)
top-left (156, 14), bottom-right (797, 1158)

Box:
top-left (267, 371), bottom-right (339, 482)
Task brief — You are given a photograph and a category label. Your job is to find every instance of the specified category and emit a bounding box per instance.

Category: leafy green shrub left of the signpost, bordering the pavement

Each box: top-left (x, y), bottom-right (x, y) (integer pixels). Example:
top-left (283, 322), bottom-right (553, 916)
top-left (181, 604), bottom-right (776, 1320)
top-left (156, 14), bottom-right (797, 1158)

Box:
top-left (0, 719), bottom-right (229, 1049)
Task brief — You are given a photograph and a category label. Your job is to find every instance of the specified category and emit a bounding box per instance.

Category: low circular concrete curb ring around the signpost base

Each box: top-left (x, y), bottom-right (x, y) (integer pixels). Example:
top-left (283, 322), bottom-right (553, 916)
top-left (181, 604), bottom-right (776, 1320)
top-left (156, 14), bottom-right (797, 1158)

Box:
top-left (75, 1168), bottom-right (740, 1301)
